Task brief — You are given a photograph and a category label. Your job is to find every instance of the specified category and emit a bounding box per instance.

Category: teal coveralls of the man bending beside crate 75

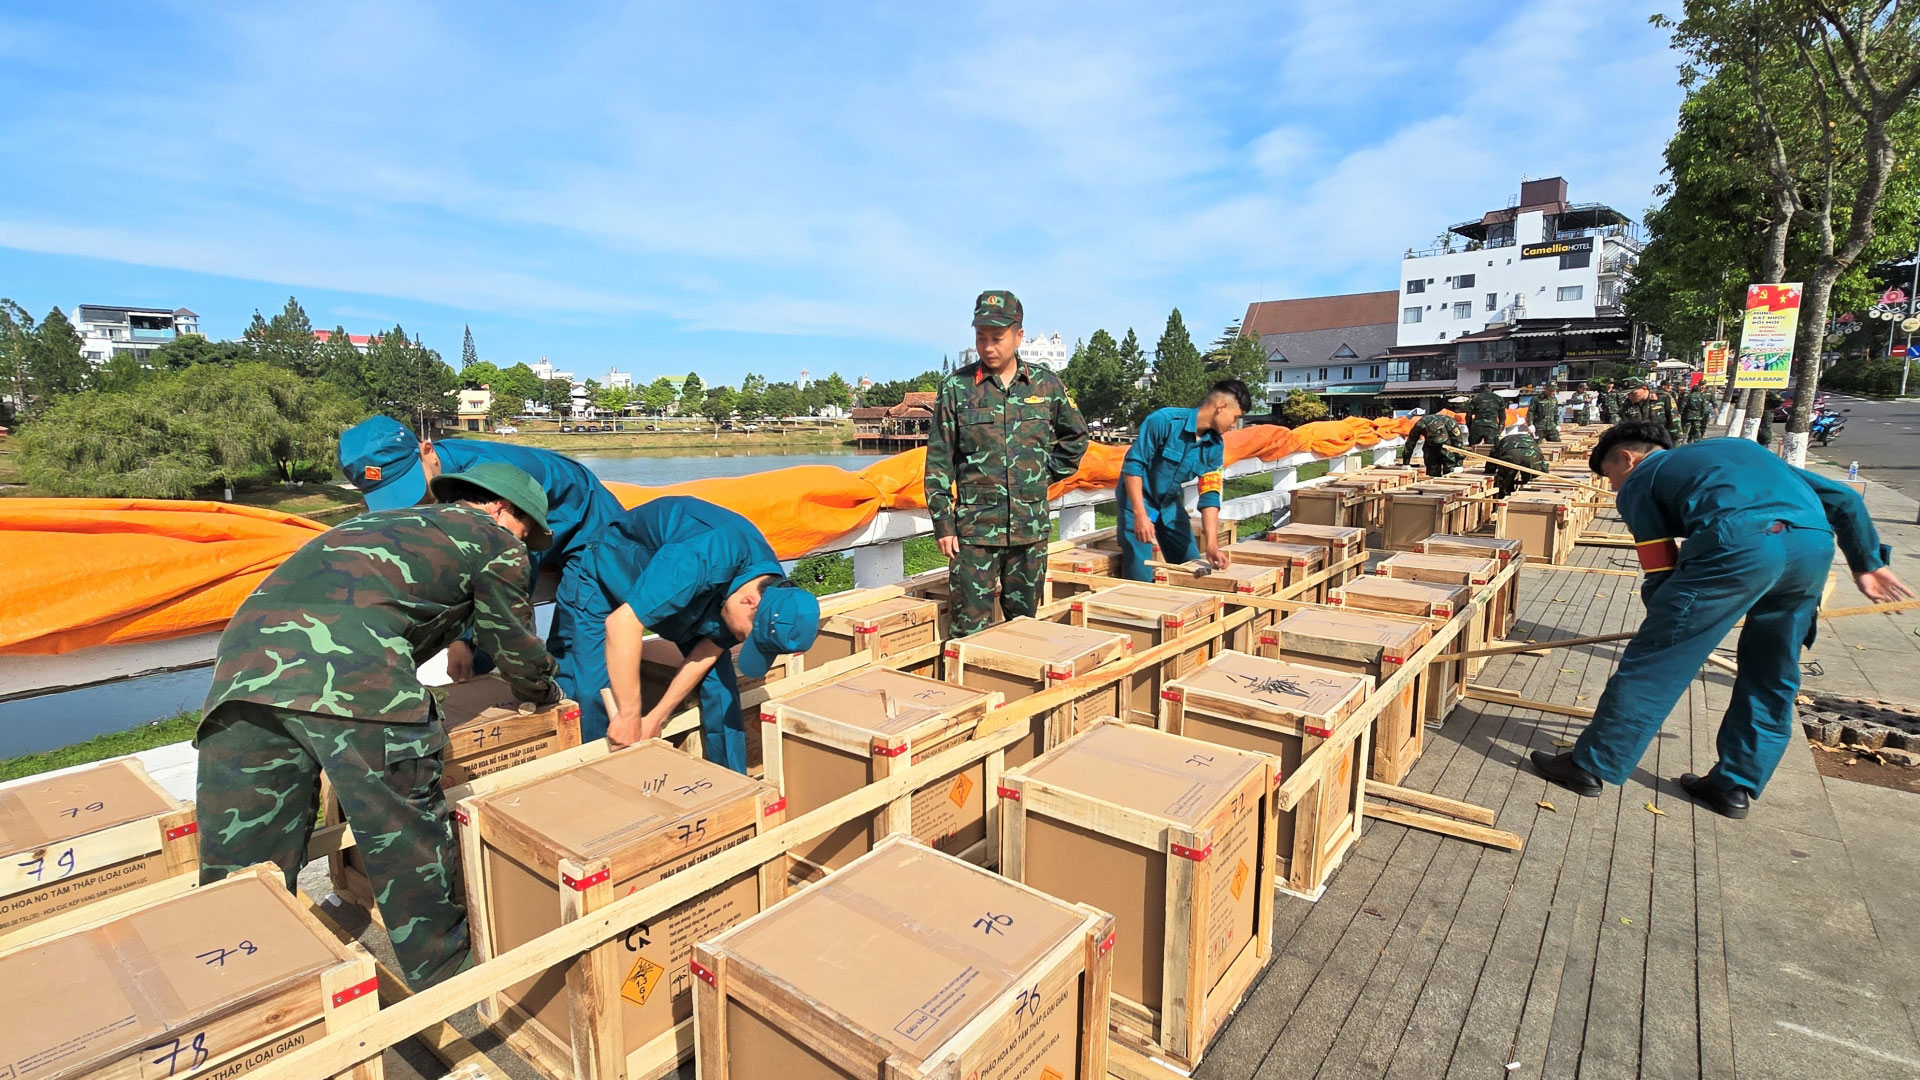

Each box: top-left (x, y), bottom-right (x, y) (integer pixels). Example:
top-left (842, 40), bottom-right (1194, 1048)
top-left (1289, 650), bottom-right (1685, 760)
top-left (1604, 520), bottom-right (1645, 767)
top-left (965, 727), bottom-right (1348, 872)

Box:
top-left (555, 496), bottom-right (785, 773)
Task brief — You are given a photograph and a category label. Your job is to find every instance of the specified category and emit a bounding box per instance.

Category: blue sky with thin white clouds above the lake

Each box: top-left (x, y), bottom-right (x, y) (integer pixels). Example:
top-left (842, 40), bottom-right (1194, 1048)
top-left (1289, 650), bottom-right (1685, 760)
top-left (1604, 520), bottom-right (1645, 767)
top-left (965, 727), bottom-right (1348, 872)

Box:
top-left (0, 0), bottom-right (1680, 382)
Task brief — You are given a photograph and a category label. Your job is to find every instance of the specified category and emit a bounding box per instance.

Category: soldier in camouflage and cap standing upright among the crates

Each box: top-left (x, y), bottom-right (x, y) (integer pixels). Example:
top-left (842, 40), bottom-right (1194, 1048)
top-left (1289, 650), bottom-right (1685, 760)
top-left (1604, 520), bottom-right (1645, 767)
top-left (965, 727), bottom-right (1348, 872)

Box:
top-left (925, 288), bottom-right (1087, 638)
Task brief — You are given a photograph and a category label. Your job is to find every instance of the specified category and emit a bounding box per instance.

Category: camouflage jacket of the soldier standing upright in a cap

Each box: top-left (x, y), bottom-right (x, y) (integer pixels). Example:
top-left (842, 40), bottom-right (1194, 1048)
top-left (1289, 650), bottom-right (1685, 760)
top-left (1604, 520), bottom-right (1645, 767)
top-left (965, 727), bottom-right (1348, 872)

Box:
top-left (925, 363), bottom-right (1087, 548)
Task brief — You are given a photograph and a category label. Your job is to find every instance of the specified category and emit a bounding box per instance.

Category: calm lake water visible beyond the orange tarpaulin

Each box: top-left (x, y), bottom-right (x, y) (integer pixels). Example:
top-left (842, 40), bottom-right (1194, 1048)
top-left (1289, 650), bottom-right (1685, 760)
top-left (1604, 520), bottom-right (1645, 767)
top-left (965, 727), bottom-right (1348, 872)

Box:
top-left (0, 448), bottom-right (885, 757)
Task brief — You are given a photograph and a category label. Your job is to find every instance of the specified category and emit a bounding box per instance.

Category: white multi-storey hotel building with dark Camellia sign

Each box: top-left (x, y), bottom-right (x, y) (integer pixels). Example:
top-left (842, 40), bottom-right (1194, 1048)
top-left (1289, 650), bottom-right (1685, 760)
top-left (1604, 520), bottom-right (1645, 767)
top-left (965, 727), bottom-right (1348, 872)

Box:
top-left (1396, 177), bottom-right (1640, 346)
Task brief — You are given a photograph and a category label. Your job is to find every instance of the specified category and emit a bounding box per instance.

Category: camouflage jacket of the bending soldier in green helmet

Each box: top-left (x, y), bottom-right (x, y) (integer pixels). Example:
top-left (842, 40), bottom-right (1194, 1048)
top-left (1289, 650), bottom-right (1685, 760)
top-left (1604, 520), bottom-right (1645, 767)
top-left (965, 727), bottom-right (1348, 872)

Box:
top-left (202, 505), bottom-right (555, 724)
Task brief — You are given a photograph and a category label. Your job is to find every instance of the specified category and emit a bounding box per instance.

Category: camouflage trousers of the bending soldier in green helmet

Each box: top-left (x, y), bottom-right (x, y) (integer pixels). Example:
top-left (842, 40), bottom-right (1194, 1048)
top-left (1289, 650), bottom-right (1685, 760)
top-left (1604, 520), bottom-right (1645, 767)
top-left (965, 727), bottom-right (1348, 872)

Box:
top-left (196, 701), bottom-right (468, 990)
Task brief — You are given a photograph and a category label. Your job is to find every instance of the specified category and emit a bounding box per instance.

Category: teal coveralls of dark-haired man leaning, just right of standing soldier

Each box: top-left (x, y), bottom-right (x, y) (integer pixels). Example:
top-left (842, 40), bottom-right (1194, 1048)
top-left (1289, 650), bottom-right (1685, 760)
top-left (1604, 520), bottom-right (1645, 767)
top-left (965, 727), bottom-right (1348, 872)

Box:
top-left (1116, 409), bottom-right (1227, 580)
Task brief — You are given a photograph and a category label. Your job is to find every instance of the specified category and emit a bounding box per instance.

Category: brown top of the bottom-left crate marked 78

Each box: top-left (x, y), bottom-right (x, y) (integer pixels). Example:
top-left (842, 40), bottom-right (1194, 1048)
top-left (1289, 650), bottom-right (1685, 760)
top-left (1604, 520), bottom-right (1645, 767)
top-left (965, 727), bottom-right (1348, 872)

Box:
top-left (0, 874), bottom-right (342, 1080)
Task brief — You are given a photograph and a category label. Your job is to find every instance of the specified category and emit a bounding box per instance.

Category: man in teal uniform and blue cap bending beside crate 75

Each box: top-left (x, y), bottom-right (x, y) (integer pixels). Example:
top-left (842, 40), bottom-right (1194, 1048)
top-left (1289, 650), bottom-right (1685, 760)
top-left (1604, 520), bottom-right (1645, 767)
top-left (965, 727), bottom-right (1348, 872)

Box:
top-left (557, 496), bottom-right (820, 760)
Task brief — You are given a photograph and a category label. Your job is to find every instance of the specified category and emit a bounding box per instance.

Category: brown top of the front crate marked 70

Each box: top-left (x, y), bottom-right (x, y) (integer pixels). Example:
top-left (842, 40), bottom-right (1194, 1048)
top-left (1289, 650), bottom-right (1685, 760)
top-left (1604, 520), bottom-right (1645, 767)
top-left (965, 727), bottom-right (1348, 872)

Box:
top-left (707, 838), bottom-right (1104, 1060)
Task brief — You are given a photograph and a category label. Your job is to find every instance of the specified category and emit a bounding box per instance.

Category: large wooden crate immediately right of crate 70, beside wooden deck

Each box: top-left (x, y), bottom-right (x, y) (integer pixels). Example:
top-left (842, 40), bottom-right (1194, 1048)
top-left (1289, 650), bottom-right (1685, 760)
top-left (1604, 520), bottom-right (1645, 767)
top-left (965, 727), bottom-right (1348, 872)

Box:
top-left (1000, 721), bottom-right (1277, 1068)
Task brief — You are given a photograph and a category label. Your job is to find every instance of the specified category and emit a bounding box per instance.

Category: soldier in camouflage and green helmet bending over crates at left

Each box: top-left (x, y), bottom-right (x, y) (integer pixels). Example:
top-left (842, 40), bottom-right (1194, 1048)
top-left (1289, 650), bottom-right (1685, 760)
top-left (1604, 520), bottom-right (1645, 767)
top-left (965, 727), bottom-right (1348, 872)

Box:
top-left (196, 463), bottom-right (559, 988)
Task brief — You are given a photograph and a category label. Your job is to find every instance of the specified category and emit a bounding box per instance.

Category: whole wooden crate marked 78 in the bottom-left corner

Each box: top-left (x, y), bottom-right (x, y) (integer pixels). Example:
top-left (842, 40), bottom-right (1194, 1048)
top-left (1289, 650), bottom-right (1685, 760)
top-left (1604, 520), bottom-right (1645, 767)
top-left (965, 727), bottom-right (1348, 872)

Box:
top-left (0, 867), bottom-right (382, 1080)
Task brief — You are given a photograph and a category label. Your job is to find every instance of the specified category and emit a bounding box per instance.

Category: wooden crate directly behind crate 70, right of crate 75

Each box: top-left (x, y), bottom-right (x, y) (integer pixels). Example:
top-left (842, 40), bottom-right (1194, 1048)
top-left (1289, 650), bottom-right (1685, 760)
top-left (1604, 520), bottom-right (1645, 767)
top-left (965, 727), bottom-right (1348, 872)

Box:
top-left (760, 667), bottom-right (1004, 880)
